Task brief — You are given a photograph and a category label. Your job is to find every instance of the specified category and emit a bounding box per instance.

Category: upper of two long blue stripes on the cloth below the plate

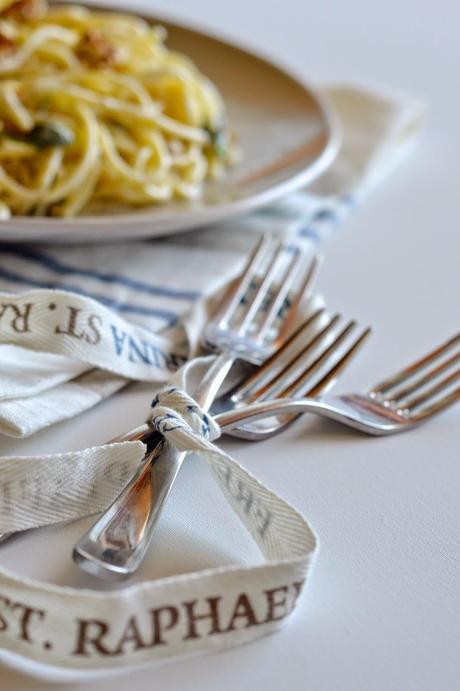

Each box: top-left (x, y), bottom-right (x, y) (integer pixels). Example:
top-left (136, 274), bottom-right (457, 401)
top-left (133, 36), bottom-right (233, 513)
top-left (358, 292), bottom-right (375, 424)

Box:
top-left (2, 246), bottom-right (201, 302)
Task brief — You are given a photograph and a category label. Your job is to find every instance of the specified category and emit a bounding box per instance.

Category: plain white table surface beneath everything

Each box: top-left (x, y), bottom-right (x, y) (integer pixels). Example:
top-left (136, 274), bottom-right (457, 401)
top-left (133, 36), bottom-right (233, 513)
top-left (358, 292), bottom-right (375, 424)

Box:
top-left (0, 0), bottom-right (460, 691)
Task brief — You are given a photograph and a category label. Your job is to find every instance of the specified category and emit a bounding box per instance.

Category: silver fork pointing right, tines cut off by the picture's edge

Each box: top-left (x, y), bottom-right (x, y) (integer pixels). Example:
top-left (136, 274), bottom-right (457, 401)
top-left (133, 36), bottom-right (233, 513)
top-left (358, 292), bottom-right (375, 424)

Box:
top-left (215, 333), bottom-right (460, 441)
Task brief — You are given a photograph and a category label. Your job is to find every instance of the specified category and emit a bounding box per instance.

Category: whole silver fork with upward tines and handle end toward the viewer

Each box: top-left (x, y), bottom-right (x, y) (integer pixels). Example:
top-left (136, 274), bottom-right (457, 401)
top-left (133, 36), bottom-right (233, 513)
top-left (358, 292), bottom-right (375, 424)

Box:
top-left (73, 236), bottom-right (319, 580)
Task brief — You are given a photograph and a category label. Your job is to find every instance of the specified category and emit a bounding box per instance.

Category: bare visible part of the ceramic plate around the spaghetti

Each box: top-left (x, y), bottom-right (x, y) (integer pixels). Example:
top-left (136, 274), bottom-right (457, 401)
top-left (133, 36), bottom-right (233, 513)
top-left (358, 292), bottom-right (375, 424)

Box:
top-left (0, 4), bottom-right (340, 242)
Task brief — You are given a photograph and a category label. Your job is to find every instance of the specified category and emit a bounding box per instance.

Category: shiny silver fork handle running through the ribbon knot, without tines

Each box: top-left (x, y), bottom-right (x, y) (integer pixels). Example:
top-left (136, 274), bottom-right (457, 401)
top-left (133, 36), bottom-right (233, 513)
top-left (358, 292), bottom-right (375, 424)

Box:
top-left (73, 354), bottom-right (235, 580)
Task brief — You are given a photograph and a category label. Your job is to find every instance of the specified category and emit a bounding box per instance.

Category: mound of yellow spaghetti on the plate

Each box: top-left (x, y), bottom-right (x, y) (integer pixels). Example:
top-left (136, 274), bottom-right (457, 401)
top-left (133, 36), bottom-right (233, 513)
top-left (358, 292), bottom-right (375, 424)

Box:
top-left (0, 0), bottom-right (234, 218)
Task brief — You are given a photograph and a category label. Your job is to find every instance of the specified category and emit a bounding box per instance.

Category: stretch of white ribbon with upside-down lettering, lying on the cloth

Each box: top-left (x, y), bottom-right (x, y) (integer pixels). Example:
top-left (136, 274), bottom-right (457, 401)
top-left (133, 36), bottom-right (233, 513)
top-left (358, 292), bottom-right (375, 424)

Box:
top-left (0, 290), bottom-right (189, 382)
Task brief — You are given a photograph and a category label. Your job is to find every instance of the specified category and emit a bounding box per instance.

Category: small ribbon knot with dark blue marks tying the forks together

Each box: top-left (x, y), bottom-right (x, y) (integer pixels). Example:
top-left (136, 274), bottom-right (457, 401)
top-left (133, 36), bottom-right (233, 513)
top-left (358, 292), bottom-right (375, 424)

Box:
top-left (152, 386), bottom-right (221, 447)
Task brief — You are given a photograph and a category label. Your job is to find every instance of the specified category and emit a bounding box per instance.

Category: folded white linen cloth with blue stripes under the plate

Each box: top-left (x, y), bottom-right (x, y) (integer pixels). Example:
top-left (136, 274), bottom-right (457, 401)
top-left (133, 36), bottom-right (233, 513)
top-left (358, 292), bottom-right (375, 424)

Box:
top-left (0, 86), bottom-right (423, 437)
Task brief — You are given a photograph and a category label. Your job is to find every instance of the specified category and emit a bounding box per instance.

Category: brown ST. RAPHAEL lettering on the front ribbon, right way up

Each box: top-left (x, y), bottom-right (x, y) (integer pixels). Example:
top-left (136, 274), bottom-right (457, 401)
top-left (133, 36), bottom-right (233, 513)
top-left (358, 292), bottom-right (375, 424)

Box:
top-left (0, 582), bottom-right (303, 658)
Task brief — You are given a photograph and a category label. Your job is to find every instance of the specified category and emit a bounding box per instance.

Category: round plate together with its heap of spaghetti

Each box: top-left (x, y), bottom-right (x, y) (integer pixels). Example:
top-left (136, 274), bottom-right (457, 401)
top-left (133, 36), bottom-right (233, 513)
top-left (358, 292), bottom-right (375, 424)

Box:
top-left (0, 0), bottom-right (339, 241)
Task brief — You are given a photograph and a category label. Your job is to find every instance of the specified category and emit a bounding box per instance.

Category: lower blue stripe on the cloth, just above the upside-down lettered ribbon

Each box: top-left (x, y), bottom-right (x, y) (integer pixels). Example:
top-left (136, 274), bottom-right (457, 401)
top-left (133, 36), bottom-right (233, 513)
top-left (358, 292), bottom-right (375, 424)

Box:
top-left (0, 267), bottom-right (178, 326)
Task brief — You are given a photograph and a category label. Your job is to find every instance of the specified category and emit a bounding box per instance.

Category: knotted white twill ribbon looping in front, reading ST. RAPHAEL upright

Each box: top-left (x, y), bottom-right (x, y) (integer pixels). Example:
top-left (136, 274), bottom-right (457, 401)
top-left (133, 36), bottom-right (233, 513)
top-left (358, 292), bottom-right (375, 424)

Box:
top-left (0, 358), bottom-right (317, 673)
